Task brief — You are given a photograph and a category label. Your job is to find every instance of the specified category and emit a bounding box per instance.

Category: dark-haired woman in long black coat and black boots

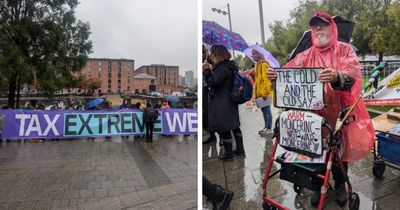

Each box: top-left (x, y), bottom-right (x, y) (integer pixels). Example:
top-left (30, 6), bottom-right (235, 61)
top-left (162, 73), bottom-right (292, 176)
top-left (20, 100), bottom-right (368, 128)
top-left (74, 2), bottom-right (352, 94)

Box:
top-left (203, 45), bottom-right (245, 161)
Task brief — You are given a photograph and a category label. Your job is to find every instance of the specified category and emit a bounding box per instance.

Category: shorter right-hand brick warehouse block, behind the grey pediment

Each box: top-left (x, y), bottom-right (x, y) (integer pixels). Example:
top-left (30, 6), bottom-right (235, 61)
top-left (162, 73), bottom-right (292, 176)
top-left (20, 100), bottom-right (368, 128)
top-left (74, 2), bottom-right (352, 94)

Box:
top-left (133, 64), bottom-right (182, 94)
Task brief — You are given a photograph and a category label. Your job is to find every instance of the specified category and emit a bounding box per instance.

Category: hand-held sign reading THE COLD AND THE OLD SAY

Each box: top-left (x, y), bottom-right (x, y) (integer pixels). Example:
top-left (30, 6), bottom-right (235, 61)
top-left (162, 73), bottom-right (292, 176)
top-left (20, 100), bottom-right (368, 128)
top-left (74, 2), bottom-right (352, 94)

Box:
top-left (274, 68), bottom-right (324, 110)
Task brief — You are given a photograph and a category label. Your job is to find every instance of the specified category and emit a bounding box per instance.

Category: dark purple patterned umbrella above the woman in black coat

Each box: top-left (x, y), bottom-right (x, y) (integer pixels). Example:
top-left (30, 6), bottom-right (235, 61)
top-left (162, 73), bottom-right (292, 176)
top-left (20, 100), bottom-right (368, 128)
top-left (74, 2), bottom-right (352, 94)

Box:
top-left (203, 20), bottom-right (248, 52)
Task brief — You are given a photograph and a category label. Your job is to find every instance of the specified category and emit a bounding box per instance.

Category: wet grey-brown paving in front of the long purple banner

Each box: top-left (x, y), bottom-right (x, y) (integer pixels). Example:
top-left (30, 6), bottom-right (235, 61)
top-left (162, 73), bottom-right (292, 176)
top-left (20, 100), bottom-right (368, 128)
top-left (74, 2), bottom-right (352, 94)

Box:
top-left (0, 135), bottom-right (197, 210)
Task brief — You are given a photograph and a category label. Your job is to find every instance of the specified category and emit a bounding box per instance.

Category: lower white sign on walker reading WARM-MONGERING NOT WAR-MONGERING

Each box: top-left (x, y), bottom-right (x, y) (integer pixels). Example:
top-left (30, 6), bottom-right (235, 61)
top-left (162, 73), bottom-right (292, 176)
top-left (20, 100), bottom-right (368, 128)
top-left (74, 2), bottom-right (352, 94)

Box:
top-left (279, 110), bottom-right (323, 156)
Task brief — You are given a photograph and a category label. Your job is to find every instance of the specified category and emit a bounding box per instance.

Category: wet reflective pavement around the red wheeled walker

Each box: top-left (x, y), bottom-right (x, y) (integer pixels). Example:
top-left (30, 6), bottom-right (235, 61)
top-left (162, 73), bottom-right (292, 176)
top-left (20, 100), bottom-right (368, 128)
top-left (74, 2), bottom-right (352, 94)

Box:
top-left (203, 107), bottom-right (400, 210)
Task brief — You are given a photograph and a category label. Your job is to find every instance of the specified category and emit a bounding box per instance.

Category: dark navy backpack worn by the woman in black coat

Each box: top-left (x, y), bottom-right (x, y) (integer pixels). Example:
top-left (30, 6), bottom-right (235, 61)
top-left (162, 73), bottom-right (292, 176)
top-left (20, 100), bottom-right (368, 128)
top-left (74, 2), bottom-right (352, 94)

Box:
top-left (229, 71), bottom-right (253, 104)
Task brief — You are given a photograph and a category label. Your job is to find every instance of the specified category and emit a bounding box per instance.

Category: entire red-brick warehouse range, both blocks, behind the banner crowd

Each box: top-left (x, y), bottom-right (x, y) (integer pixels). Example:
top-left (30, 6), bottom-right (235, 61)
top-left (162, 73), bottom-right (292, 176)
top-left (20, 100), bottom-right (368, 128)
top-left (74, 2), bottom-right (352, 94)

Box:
top-left (79, 58), bottom-right (182, 94)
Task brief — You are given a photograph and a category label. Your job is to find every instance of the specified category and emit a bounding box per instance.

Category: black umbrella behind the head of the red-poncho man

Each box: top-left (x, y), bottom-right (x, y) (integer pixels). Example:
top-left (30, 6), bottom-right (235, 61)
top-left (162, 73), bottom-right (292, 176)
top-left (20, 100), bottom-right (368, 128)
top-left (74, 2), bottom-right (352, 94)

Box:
top-left (289, 16), bottom-right (357, 61)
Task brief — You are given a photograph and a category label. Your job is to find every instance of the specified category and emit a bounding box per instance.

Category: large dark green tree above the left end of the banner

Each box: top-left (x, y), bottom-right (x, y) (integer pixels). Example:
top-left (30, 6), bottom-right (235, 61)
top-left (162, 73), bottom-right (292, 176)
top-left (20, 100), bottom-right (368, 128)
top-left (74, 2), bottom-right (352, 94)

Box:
top-left (0, 0), bottom-right (92, 107)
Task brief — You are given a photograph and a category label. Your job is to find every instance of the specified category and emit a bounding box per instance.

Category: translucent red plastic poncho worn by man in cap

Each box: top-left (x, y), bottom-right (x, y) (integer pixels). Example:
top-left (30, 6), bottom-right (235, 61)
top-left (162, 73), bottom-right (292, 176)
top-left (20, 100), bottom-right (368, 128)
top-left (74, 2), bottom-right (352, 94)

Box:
top-left (285, 11), bottom-right (375, 162)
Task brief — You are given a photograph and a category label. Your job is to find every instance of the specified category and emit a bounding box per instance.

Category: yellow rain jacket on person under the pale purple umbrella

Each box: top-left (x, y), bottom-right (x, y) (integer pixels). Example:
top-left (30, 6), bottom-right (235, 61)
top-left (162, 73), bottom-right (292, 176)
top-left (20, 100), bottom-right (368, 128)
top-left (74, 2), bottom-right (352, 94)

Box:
top-left (254, 61), bottom-right (272, 98)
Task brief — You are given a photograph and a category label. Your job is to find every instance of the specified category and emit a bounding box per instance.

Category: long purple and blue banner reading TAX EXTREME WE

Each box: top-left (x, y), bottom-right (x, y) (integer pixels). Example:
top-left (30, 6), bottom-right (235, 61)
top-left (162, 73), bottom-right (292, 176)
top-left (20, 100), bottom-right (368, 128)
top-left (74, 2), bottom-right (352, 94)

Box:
top-left (0, 109), bottom-right (198, 139)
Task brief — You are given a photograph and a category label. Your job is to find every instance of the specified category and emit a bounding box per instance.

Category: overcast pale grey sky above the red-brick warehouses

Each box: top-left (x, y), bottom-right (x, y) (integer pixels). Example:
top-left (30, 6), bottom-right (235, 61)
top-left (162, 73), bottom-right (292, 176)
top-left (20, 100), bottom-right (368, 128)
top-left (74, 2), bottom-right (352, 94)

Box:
top-left (76, 0), bottom-right (198, 75)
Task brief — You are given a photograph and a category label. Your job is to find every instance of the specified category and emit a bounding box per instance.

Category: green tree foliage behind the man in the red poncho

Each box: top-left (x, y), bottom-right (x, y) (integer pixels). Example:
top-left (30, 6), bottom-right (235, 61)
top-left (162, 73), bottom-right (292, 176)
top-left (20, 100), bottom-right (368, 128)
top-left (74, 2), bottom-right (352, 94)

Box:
top-left (264, 0), bottom-right (400, 64)
